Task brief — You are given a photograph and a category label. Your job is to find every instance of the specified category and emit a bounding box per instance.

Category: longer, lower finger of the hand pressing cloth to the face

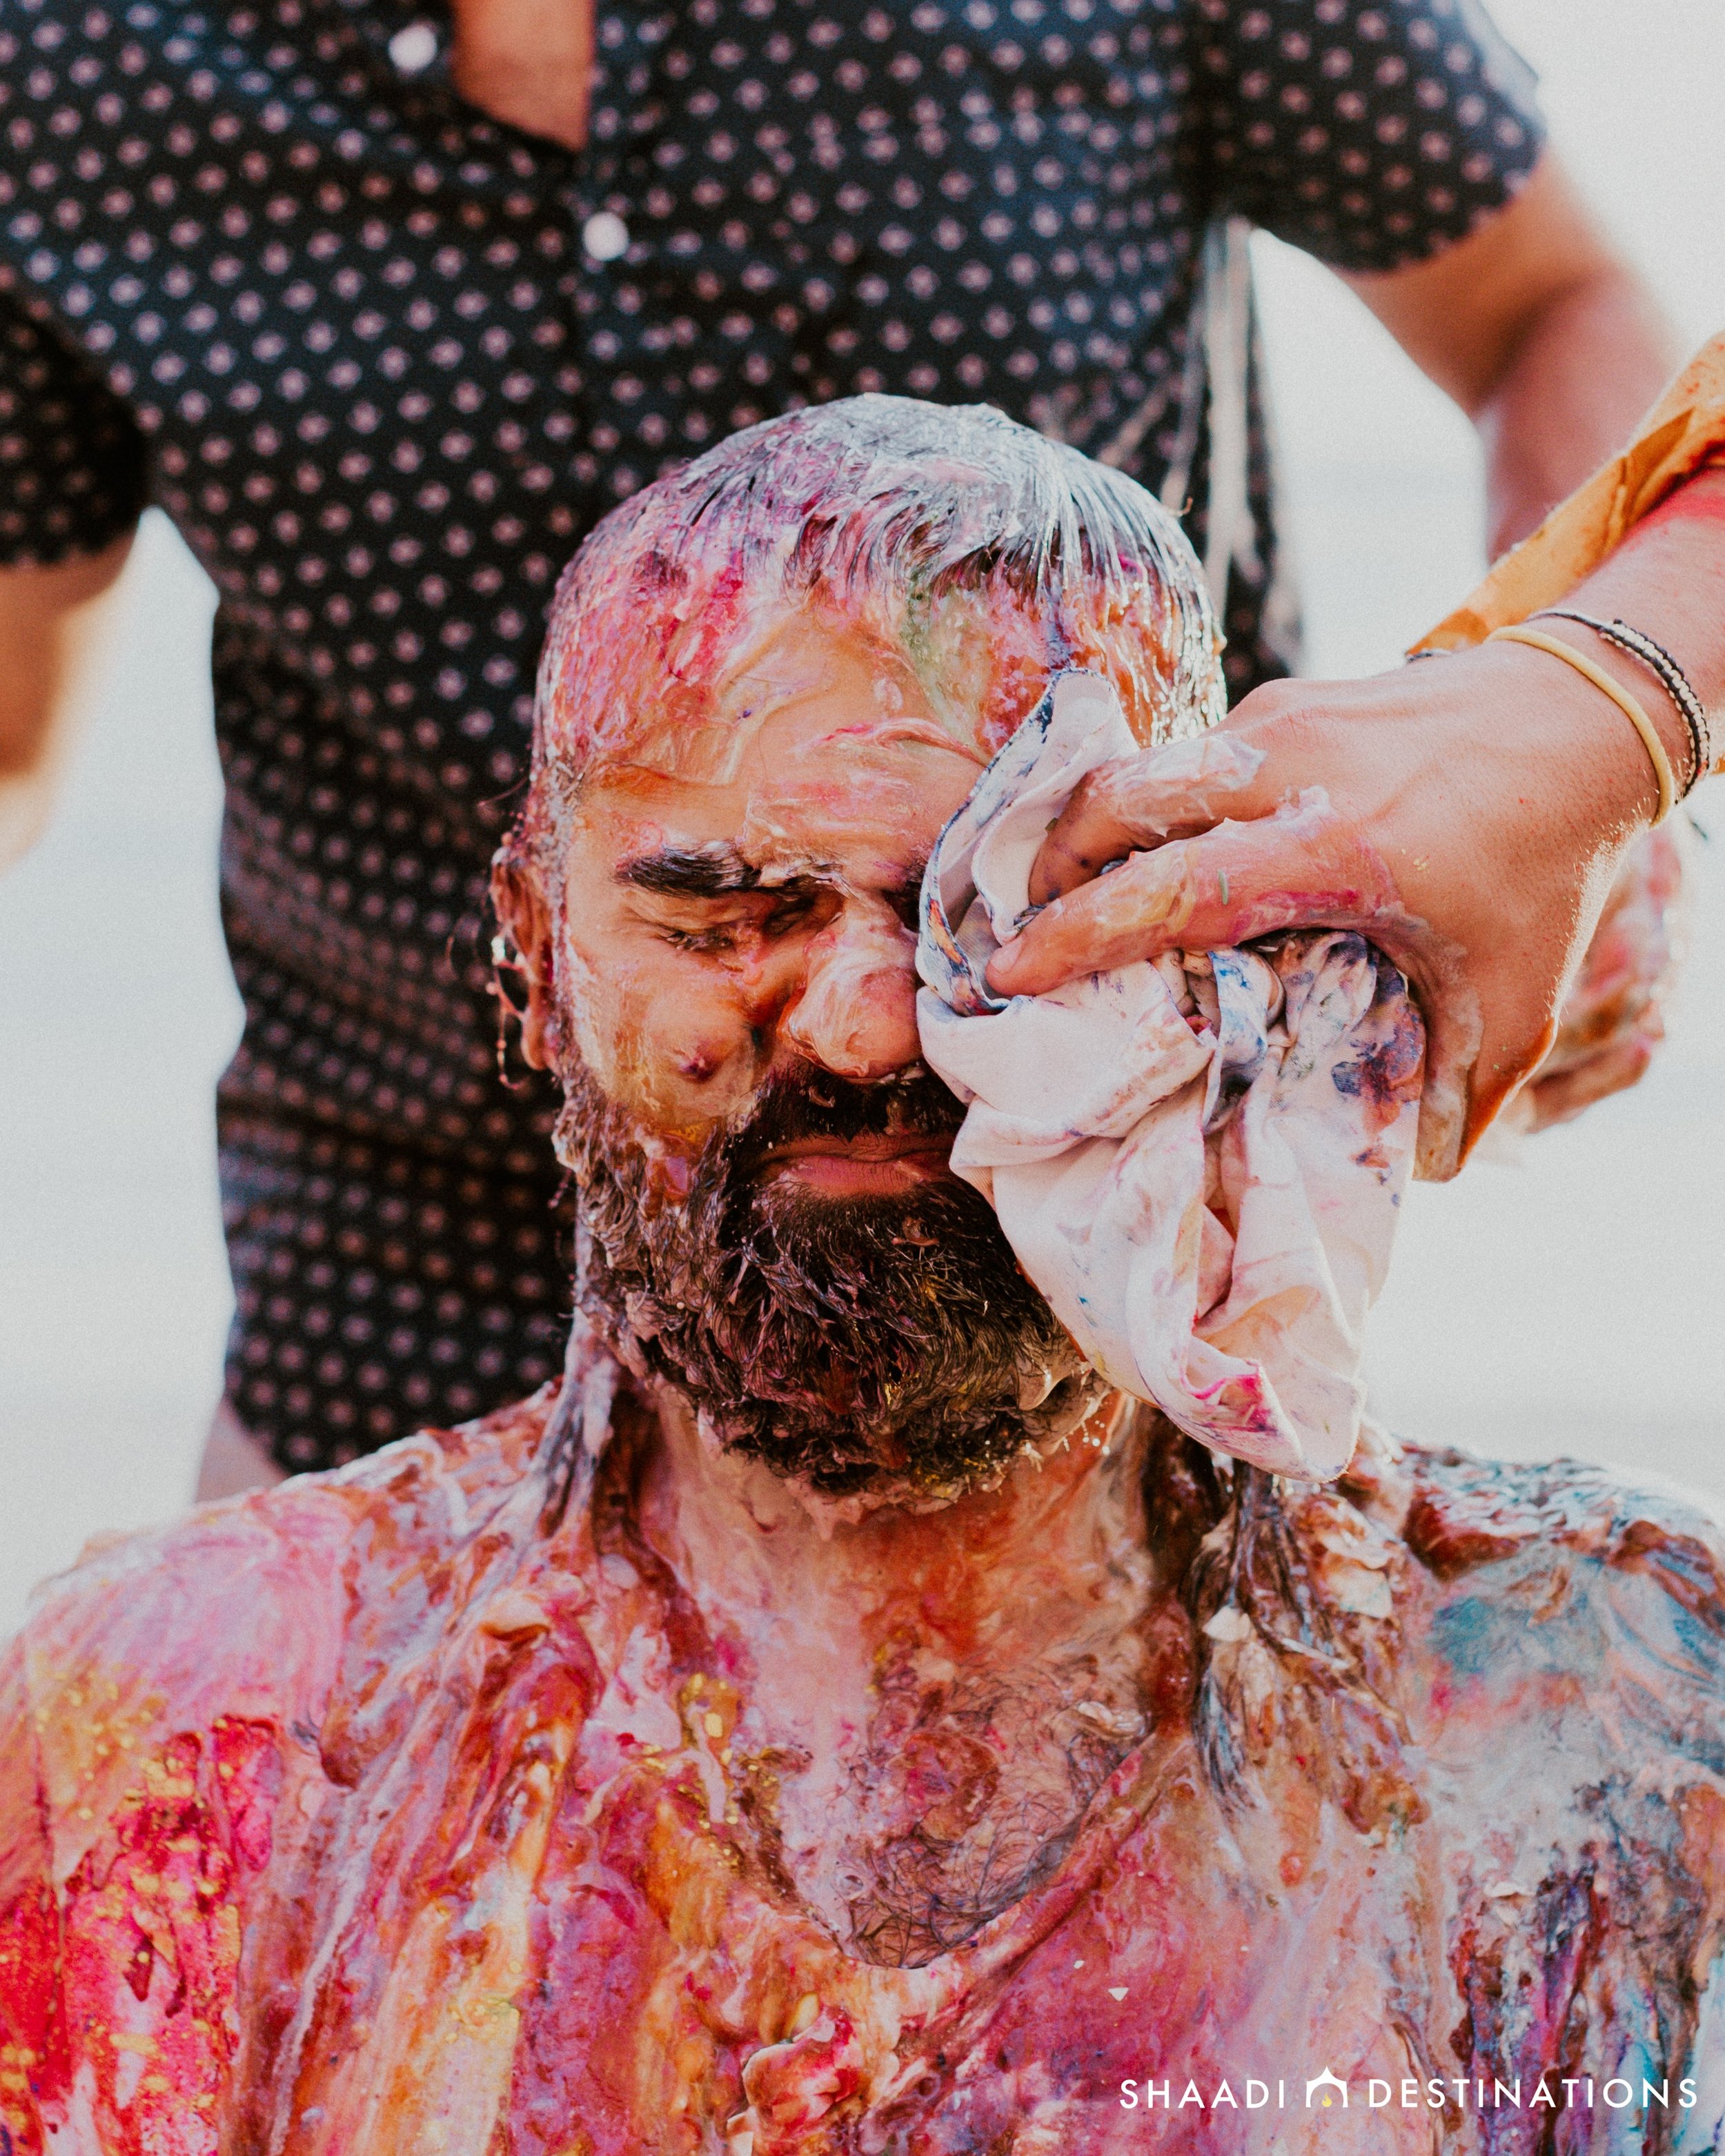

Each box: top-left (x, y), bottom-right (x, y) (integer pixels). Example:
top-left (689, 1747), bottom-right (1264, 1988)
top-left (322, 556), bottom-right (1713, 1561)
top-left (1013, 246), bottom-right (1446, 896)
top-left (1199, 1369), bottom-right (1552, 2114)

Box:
top-left (987, 795), bottom-right (1406, 996)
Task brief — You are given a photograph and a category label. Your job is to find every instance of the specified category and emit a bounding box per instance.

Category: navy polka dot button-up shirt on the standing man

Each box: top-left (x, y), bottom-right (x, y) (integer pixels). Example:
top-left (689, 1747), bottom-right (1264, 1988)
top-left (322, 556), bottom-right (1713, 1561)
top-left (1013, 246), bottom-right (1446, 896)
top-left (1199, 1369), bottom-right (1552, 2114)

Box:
top-left (0, 0), bottom-right (1539, 1466)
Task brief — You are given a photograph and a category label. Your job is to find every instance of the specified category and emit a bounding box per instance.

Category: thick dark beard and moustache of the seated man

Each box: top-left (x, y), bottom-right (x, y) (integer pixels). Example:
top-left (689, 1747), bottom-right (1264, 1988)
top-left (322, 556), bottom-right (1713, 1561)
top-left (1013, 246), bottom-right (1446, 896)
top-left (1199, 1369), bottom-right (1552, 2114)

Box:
top-left (556, 1067), bottom-right (1098, 1501)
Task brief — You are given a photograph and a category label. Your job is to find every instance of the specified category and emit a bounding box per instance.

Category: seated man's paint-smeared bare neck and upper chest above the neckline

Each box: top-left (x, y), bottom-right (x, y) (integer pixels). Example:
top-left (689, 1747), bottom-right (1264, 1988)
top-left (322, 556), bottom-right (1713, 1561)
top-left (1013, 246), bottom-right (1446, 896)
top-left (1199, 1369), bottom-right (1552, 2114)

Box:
top-left (638, 1395), bottom-right (1158, 1960)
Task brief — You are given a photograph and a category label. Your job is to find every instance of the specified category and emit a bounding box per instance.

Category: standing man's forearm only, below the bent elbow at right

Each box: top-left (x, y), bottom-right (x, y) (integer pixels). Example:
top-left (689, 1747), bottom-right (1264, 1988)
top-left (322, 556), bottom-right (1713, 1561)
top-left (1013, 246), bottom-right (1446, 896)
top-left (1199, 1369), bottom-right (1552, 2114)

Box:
top-left (1472, 263), bottom-right (1679, 561)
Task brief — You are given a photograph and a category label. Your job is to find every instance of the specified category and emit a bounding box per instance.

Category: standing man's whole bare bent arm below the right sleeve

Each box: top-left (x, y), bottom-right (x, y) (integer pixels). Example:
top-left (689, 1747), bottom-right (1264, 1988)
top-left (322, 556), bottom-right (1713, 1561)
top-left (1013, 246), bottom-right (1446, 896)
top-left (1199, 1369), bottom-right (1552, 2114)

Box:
top-left (1346, 151), bottom-right (1679, 558)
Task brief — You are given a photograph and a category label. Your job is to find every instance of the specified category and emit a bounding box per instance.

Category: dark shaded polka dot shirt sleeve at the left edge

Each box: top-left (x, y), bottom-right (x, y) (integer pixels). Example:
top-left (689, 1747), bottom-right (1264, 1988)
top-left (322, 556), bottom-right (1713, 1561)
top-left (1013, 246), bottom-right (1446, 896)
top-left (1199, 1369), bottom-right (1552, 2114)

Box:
top-left (0, 291), bottom-right (149, 569)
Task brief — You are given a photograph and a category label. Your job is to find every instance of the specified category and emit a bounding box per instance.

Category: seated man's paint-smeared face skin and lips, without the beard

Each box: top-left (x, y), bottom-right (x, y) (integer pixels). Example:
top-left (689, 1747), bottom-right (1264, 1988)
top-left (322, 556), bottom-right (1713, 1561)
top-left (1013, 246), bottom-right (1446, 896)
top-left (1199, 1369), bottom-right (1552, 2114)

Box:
top-left (565, 615), bottom-right (985, 1138)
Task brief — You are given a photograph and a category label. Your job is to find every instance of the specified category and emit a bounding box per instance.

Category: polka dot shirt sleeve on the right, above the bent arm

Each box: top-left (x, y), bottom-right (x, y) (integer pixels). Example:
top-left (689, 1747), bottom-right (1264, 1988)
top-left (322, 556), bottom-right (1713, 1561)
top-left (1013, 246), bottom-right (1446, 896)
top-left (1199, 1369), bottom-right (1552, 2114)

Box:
top-left (1194, 0), bottom-right (1544, 270)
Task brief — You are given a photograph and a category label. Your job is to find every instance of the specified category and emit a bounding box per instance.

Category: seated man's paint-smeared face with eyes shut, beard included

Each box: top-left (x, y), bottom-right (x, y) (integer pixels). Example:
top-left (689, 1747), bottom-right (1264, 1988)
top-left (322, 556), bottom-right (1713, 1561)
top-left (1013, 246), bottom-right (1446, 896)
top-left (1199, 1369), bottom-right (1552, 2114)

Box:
top-left (543, 613), bottom-right (1076, 1492)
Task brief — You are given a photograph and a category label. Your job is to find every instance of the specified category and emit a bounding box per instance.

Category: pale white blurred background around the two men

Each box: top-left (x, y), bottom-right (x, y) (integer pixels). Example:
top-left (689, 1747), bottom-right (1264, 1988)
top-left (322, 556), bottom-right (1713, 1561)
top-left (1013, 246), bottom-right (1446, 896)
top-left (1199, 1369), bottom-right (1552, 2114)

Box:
top-left (0, 0), bottom-right (1725, 1630)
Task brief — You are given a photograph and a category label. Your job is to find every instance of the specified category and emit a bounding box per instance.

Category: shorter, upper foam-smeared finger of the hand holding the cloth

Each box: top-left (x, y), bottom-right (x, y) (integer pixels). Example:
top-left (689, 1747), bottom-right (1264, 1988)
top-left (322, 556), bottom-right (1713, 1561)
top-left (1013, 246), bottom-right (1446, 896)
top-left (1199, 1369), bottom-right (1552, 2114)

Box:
top-left (1031, 733), bottom-right (1270, 906)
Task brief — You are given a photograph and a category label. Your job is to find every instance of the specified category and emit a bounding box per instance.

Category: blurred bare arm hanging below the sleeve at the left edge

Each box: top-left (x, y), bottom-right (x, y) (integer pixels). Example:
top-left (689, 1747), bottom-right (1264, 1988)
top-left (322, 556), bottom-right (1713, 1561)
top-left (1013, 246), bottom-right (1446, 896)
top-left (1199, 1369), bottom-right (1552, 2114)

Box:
top-left (0, 537), bottom-right (132, 871)
